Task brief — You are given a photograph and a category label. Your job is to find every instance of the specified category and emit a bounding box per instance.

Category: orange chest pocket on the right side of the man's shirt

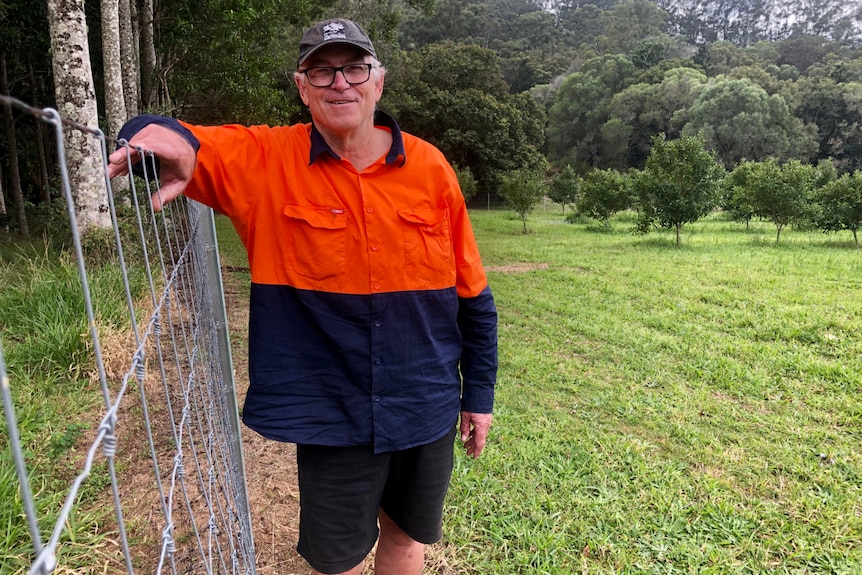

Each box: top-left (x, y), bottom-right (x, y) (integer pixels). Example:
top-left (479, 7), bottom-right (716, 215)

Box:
top-left (398, 209), bottom-right (454, 281)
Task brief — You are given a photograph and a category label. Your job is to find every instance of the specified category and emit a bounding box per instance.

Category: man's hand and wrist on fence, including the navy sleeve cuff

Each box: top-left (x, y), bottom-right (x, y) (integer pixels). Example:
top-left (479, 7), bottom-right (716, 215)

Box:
top-left (108, 116), bottom-right (200, 211)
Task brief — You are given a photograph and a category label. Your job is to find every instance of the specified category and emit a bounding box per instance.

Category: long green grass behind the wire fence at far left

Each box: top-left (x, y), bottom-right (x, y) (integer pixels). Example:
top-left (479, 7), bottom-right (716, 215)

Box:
top-left (0, 237), bottom-right (144, 575)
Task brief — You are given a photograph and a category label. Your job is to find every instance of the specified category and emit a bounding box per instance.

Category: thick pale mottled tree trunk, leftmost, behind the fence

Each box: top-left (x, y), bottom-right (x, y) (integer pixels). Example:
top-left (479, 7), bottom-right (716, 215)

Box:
top-left (48, 0), bottom-right (111, 234)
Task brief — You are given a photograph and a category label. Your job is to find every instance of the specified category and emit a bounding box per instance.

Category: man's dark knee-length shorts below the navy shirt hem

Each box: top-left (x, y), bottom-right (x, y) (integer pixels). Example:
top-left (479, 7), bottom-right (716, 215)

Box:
top-left (296, 427), bottom-right (455, 573)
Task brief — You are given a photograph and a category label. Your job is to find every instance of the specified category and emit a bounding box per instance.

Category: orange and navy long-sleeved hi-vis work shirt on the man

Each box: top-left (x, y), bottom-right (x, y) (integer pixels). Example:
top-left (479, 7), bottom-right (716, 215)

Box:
top-left (120, 112), bottom-right (497, 452)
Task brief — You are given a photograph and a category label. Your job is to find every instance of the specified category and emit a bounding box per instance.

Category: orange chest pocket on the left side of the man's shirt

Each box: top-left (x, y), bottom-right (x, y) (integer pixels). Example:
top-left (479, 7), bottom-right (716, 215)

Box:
top-left (284, 204), bottom-right (347, 280)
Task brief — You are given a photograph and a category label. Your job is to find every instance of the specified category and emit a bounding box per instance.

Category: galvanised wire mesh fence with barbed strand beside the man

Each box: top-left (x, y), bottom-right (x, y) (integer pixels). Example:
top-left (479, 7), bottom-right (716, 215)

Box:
top-left (0, 95), bottom-right (256, 575)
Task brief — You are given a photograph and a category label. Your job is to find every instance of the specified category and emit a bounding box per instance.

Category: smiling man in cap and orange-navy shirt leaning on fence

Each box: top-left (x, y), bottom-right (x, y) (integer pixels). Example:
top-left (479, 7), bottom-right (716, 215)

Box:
top-left (109, 19), bottom-right (497, 575)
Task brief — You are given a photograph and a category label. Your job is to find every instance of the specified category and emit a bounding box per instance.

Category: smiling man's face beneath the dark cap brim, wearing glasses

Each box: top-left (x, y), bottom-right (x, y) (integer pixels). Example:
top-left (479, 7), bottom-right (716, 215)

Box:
top-left (296, 44), bottom-right (383, 133)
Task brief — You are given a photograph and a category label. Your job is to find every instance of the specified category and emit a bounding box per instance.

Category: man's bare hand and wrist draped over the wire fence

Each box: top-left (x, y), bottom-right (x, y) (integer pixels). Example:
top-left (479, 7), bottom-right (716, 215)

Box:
top-left (108, 124), bottom-right (197, 211)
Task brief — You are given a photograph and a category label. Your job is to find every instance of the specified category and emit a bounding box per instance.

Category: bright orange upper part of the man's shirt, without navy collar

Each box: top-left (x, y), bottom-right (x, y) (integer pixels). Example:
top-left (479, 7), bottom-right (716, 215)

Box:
top-left (186, 124), bottom-right (487, 297)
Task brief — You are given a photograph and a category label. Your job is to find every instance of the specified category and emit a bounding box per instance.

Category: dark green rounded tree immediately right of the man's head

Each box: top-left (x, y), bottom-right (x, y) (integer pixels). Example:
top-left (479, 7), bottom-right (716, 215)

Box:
top-left (381, 43), bottom-right (545, 191)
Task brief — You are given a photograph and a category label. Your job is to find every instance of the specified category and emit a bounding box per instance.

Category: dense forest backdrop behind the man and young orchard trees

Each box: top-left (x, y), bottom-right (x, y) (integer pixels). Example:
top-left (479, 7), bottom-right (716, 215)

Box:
top-left (5, 0), bottom-right (862, 231)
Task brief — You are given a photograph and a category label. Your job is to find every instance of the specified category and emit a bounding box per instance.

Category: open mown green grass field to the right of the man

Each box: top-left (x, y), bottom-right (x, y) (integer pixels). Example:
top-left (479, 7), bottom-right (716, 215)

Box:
top-left (446, 211), bottom-right (862, 575)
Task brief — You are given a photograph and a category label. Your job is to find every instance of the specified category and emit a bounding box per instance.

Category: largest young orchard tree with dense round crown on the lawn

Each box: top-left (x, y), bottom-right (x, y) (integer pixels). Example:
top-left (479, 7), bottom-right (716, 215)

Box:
top-left (636, 135), bottom-right (724, 245)
